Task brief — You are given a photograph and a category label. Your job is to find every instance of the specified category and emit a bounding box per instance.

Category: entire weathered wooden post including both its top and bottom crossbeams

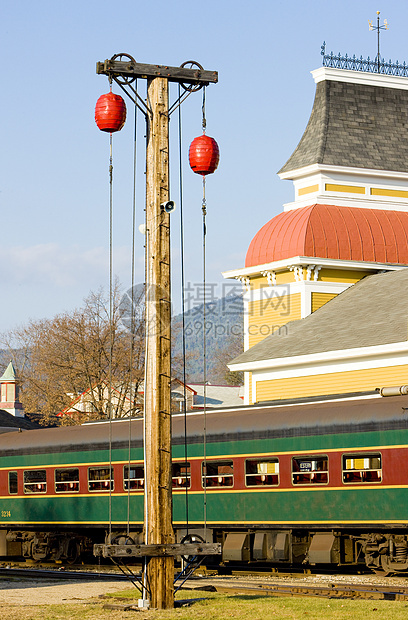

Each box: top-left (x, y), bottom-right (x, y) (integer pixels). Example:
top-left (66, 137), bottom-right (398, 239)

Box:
top-left (94, 54), bottom-right (220, 609)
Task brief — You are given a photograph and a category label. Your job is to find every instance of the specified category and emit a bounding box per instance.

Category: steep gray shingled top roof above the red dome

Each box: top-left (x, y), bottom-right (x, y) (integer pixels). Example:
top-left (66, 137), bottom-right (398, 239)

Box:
top-left (279, 80), bottom-right (408, 172)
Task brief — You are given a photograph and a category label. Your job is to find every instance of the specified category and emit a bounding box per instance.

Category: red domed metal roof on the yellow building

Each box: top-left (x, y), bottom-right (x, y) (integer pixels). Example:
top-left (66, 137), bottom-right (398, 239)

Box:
top-left (245, 204), bottom-right (408, 267)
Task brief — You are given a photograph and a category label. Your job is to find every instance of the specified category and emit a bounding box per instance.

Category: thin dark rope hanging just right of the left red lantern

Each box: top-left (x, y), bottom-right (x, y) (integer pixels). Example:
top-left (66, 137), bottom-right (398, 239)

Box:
top-left (127, 80), bottom-right (137, 536)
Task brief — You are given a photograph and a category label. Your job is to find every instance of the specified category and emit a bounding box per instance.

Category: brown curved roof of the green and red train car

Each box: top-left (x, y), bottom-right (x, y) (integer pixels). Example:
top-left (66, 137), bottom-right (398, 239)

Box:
top-left (0, 395), bottom-right (408, 456)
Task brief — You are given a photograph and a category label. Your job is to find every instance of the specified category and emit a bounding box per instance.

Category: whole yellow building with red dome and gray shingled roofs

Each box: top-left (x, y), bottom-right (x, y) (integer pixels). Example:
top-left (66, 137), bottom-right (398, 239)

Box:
top-left (223, 59), bottom-right (408, 404)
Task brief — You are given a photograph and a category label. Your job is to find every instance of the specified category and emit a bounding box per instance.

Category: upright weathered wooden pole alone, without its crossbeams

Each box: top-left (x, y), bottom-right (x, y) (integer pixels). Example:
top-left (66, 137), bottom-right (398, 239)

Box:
top-left (144, 77), bottom-right (174, 609)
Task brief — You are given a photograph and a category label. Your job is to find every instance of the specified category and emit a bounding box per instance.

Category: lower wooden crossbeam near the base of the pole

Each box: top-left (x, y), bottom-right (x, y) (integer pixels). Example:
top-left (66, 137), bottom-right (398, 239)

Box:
top-left (94, 543), bottom-right (221, 558)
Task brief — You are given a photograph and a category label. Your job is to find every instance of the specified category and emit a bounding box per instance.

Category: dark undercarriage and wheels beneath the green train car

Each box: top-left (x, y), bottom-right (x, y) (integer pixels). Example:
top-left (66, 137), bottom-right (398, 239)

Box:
top-left (0, 528), bottom-right (408, 574)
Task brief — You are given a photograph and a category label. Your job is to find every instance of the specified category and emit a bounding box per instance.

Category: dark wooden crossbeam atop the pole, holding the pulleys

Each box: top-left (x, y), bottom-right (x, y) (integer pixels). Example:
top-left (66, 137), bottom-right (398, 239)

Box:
top-left (96, 60), bottom-right (218, 86)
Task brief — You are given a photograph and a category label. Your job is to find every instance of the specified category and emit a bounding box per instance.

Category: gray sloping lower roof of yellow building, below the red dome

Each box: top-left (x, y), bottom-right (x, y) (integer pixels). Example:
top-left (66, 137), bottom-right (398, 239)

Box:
top-left (229, 269), bottom-right (408, 364)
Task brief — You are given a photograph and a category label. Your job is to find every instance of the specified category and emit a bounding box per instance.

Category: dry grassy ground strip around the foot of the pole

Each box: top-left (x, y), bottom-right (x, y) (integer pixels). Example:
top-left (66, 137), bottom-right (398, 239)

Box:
top-left (0, 590), bottom-right (408, 620)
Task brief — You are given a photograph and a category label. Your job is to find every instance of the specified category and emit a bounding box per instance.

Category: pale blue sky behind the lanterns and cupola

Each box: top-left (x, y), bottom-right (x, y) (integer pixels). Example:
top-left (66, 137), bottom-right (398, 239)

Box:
top-left (0, 0), bottom-right (408, 331)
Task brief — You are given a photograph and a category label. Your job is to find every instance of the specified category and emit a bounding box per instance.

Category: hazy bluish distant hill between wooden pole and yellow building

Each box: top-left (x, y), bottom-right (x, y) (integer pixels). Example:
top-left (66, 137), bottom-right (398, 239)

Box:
top-left (172, 295), bottom-right (244, 384)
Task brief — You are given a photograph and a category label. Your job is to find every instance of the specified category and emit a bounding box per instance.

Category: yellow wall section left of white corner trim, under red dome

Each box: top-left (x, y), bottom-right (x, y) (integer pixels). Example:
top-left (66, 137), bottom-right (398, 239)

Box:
top-left (248, 293), bottom-right (300, 347)
